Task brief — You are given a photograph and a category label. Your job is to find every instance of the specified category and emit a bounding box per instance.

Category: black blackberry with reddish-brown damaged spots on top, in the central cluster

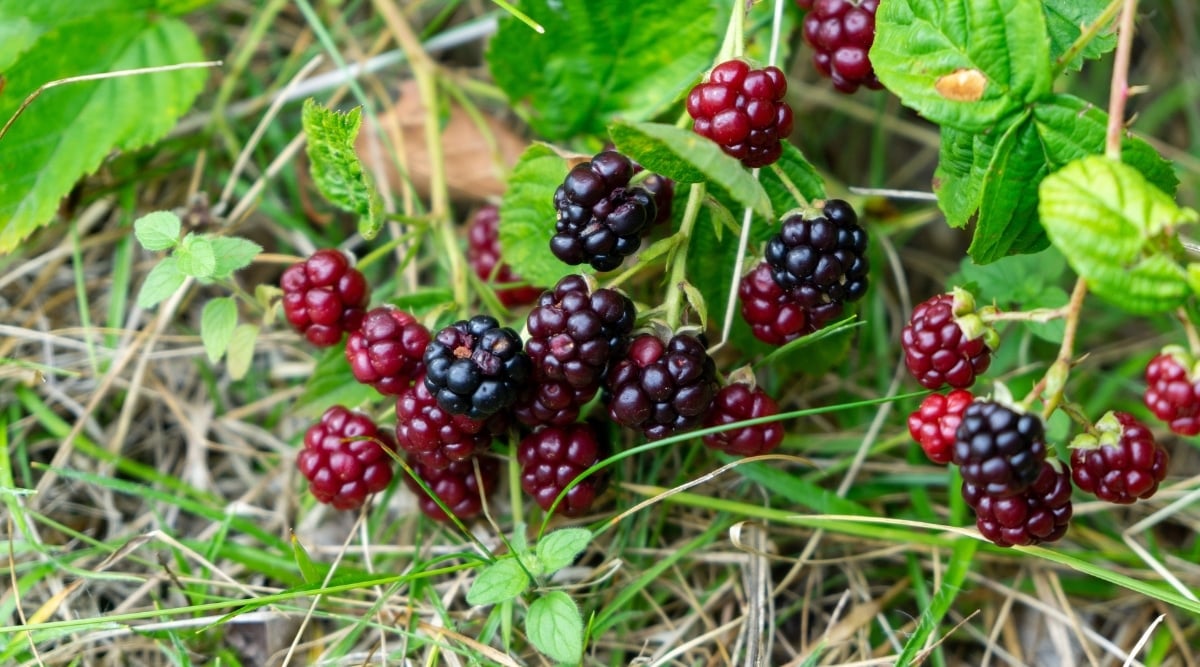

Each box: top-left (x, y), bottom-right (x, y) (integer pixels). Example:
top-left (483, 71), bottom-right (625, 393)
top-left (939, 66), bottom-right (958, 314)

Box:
top-left (425, 316), bottom-right (530, 419)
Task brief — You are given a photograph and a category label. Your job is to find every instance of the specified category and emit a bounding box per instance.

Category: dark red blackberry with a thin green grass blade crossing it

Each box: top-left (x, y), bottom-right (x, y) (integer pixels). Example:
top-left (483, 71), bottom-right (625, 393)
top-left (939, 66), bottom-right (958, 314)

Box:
top-left (702, 383), bottom-right (784, 456)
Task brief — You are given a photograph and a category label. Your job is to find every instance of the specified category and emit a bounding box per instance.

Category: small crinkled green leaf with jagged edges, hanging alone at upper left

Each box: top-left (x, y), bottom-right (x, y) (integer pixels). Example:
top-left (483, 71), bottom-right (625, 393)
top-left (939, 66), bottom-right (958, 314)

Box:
top-left (300, 97), bottom-right (383, 241)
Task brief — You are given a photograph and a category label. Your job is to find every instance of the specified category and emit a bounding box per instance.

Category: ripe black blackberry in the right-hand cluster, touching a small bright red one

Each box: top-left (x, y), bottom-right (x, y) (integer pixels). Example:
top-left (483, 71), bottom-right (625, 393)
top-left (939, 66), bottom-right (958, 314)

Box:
top-left (952, 401), bottom-right (1046, 498)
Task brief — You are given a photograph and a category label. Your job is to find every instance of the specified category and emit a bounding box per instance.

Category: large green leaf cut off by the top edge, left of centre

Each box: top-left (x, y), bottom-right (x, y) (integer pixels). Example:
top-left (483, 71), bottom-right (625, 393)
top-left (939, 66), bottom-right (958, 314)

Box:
top-left (487, 0), bottom-right (719, 140)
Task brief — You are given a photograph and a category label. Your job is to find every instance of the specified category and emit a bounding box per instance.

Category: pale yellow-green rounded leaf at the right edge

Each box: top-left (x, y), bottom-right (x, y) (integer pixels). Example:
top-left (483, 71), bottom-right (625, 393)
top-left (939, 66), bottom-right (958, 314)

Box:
top-left (1038, 156), bottom-right (1198, 314)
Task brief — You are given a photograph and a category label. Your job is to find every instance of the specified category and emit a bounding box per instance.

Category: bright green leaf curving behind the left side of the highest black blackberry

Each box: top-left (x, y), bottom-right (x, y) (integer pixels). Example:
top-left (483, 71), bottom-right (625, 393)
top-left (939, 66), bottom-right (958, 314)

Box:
top-left (500, 144), bottom-right (576, 284)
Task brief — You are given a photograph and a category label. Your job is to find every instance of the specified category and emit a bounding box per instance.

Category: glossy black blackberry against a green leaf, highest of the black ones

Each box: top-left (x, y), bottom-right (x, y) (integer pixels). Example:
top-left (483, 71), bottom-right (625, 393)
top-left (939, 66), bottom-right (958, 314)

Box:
top-left (550, 151), bottom-right (658, 271)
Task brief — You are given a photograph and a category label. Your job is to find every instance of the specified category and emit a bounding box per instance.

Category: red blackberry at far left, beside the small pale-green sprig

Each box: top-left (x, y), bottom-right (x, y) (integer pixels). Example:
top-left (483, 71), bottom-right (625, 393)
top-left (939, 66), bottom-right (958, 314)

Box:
top-left (280, 248), bottom-right (371, 348)
